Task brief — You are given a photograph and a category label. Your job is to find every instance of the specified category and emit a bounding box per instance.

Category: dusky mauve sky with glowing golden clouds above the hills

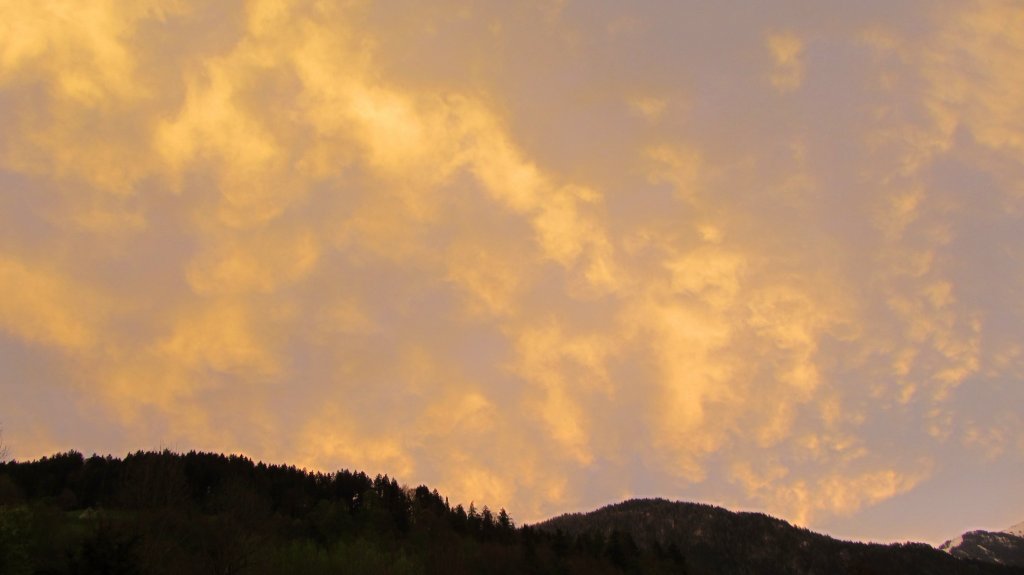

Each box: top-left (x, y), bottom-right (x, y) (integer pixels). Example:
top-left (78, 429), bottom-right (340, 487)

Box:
top-left (0, 0), bottom-right (1024, 543)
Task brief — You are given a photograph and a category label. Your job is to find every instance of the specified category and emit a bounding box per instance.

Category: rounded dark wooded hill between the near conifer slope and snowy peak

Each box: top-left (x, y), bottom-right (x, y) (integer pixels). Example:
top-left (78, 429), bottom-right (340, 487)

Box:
top-left (535, 499), bottom-right (1024, 575)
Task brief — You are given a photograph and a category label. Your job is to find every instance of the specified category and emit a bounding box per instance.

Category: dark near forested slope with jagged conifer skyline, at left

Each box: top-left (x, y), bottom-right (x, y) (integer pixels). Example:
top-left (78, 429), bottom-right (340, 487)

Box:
top-left (0, 451), bottom-right (686, 575)
